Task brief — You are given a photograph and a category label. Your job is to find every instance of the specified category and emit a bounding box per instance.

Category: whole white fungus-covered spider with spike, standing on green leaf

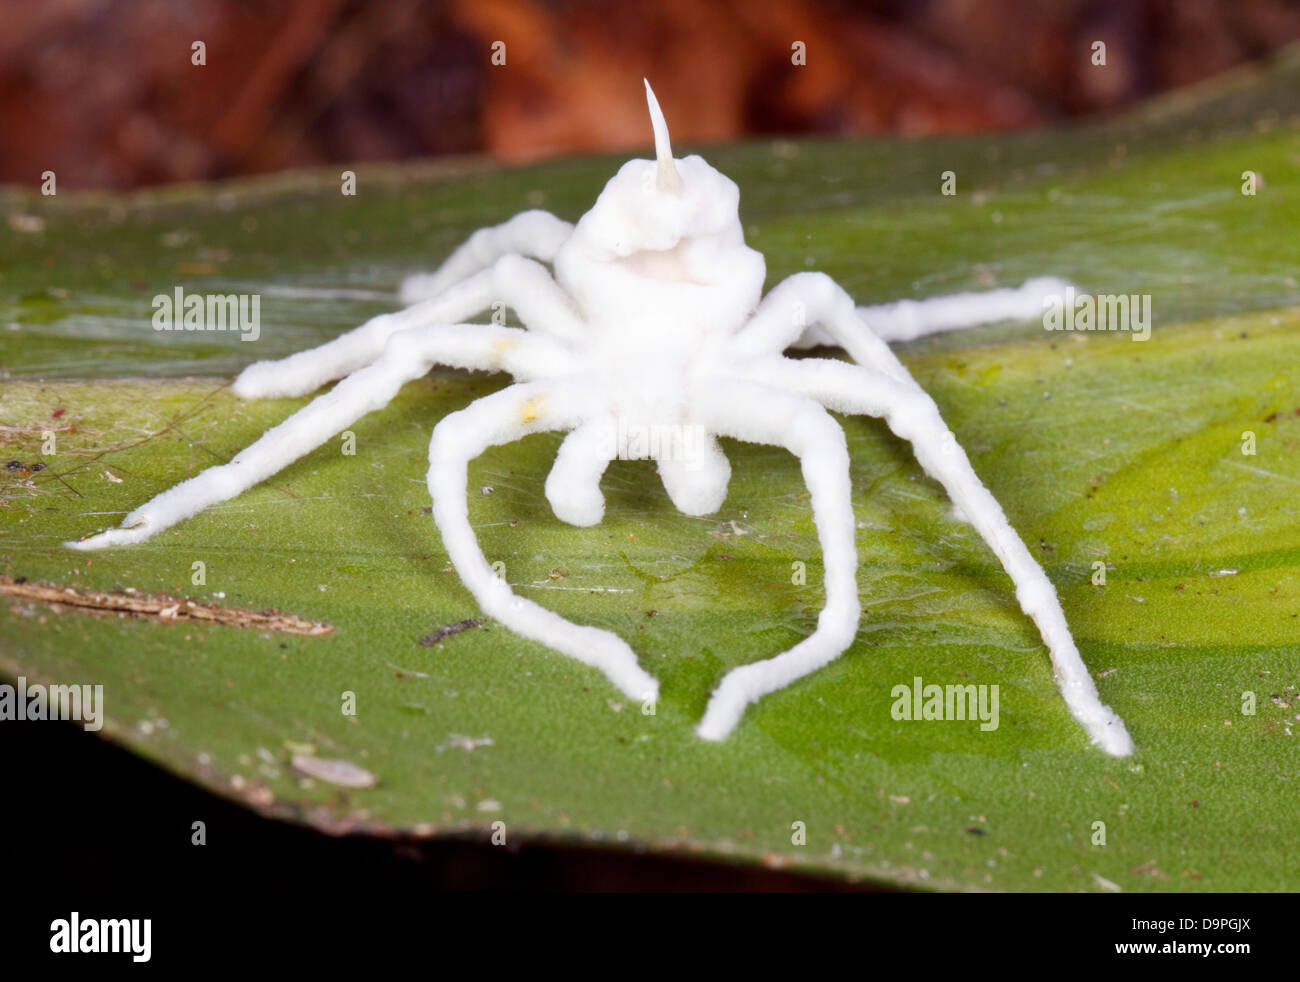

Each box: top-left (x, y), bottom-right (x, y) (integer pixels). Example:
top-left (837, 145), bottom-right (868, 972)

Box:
top-left (69, 85), bottom-right (1132, 756)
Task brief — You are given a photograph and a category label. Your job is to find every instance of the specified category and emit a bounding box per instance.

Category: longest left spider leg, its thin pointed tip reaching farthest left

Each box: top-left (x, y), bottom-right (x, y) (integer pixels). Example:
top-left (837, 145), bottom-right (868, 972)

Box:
top-left (64, 324), bottom-right (572, 549)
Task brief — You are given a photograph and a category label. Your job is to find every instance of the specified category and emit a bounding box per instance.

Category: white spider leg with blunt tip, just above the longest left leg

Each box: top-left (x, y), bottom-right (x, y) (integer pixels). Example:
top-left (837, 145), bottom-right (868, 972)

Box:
top-left (234, 255), bottom-right (585, 399)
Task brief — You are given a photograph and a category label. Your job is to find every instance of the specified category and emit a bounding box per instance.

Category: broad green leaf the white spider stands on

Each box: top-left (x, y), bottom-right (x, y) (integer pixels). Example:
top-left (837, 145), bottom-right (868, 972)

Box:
top-left (0, 55), bottom-right (1300, 891)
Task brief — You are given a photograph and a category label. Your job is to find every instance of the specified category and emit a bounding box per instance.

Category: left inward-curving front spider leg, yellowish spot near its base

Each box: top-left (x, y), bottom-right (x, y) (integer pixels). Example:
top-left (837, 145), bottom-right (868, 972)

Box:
top-left (429, 382), bottom-right (659, 700)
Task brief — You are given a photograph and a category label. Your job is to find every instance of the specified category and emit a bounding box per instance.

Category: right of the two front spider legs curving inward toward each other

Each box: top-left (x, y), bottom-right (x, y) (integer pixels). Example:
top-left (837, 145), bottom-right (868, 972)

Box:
top-left (696, 378), bottom-right (862, 740)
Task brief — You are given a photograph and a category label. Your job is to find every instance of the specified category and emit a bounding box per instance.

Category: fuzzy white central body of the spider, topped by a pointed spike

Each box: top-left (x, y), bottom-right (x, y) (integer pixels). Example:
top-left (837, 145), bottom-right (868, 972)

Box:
top-left (554, 145), bottom-right (767, 494)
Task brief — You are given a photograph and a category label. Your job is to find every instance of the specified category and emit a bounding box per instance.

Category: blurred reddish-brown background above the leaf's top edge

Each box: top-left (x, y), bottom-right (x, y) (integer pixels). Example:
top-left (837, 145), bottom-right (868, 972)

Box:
top-left (0, 0), bottom-right (1300, 190)
